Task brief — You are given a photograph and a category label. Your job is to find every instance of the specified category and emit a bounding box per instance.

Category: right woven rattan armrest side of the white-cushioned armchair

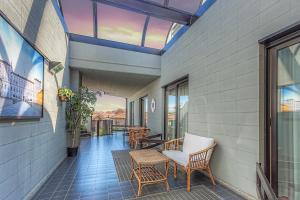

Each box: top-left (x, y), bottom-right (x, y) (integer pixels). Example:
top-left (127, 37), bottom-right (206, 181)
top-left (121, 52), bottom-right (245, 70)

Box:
top-left (188, 143), bottom-right (217, 168)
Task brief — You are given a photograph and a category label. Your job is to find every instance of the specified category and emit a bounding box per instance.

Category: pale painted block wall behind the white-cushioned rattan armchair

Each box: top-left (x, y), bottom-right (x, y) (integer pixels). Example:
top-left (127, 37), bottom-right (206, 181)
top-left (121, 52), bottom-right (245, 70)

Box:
top-left (130, 0), bottom-right (300, 197)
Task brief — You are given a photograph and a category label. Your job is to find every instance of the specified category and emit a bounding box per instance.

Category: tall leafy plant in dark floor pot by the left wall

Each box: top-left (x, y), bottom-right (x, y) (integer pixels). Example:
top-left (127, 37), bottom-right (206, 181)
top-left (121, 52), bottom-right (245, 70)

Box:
top-left (66, 87), bottom-right (97, 156)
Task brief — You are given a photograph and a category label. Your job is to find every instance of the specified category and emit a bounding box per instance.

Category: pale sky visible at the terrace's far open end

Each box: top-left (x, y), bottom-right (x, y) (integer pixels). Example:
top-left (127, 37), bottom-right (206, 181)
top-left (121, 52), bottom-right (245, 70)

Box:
top-left (95, 95), bottom-right (126, 112)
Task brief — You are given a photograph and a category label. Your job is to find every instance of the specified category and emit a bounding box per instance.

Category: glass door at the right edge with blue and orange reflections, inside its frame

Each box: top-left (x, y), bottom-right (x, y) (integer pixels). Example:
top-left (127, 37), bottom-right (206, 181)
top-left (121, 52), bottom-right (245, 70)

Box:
top-left (269, 39), bottom-right (300, 200)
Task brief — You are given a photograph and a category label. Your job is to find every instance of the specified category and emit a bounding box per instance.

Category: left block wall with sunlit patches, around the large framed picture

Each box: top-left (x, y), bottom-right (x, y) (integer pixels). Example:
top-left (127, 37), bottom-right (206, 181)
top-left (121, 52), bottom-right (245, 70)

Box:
top-left (0, 0), bottom-right (69, 200)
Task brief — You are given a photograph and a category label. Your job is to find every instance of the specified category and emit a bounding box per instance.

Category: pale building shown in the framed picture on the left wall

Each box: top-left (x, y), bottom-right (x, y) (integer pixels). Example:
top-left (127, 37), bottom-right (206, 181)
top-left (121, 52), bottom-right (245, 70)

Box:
top-left (0, 60), bottom-right (42, 103)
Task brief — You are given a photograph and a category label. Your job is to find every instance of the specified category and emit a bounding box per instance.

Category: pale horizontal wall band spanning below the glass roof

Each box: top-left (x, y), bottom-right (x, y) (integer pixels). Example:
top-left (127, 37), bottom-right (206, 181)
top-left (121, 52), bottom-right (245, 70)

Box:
top-left (70, 41), bottom-right (161, 76)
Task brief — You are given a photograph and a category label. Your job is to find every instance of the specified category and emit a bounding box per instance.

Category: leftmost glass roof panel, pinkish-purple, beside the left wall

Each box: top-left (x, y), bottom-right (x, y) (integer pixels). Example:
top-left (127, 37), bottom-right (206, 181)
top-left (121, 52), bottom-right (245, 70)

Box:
top-left (61, 0), bottom-right (94, 36)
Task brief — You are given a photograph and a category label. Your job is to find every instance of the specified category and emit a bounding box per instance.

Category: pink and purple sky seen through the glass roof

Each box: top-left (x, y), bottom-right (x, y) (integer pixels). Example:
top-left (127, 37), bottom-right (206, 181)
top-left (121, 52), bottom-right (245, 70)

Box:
top-left (62, 0), bottom-right (177, 49)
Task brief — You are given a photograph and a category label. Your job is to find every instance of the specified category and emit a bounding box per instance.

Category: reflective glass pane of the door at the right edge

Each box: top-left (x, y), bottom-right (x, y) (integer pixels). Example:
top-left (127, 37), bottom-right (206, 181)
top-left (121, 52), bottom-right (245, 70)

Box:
top-left (277, 44), bottom-right (300, 200)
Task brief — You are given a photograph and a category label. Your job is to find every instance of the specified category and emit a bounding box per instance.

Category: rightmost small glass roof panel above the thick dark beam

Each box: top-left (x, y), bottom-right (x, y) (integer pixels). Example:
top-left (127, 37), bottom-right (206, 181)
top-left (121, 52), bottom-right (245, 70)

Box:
top-left (168, 0), bottom-right (200, 14)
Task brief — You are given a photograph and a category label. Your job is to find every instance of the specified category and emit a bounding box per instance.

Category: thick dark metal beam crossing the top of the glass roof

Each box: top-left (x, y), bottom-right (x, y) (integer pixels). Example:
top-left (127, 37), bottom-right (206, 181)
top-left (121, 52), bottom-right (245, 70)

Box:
top-left (92, 0), bottom-right (198, 25)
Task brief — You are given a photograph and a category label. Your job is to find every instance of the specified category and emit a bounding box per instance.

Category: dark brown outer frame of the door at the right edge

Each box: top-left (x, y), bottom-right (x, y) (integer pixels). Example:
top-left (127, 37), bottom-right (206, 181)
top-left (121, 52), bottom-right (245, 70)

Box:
top-left (258, 22), bottom-right (300, 195)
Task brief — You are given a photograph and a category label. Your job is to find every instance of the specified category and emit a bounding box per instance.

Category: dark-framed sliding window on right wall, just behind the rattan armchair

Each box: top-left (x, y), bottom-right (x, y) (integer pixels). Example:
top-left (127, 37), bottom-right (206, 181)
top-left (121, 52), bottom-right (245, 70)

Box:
top-left (165, 78), bottom-right (189, 140)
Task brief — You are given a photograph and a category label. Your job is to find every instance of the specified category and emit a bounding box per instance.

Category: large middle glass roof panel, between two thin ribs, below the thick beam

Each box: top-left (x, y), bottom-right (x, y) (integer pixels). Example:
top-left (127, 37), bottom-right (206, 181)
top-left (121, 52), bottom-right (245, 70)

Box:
top-left (97, 4), bottom-right (146, 45)
